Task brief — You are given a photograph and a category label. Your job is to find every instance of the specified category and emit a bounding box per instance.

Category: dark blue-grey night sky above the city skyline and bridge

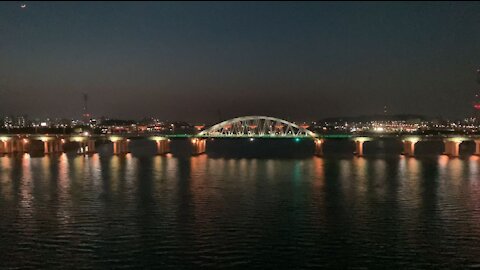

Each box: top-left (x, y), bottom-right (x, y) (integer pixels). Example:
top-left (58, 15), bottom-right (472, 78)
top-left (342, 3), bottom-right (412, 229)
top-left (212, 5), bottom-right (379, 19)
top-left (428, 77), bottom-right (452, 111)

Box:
top-left (0, 2), bottom-right (480, 122)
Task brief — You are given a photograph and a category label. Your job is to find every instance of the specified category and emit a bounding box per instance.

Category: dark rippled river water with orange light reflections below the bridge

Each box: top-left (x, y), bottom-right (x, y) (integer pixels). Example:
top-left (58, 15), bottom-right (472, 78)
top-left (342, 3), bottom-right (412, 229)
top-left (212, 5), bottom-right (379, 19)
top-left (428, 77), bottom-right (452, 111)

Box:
top-left (0, 141), bottom-right (480, 269)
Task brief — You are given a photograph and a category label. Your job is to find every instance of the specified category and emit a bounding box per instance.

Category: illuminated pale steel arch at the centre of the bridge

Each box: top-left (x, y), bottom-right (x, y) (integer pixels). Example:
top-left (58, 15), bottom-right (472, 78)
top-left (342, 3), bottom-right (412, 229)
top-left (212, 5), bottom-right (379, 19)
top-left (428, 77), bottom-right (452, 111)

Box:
top-left (197, 116), bottom-right (317, 138)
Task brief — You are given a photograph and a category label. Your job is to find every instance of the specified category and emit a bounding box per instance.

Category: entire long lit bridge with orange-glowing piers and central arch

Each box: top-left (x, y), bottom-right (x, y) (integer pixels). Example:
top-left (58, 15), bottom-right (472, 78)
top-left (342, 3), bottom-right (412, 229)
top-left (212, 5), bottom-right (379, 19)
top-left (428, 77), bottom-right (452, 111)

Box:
top-left (0, 116), bottom-right (480, 157)
